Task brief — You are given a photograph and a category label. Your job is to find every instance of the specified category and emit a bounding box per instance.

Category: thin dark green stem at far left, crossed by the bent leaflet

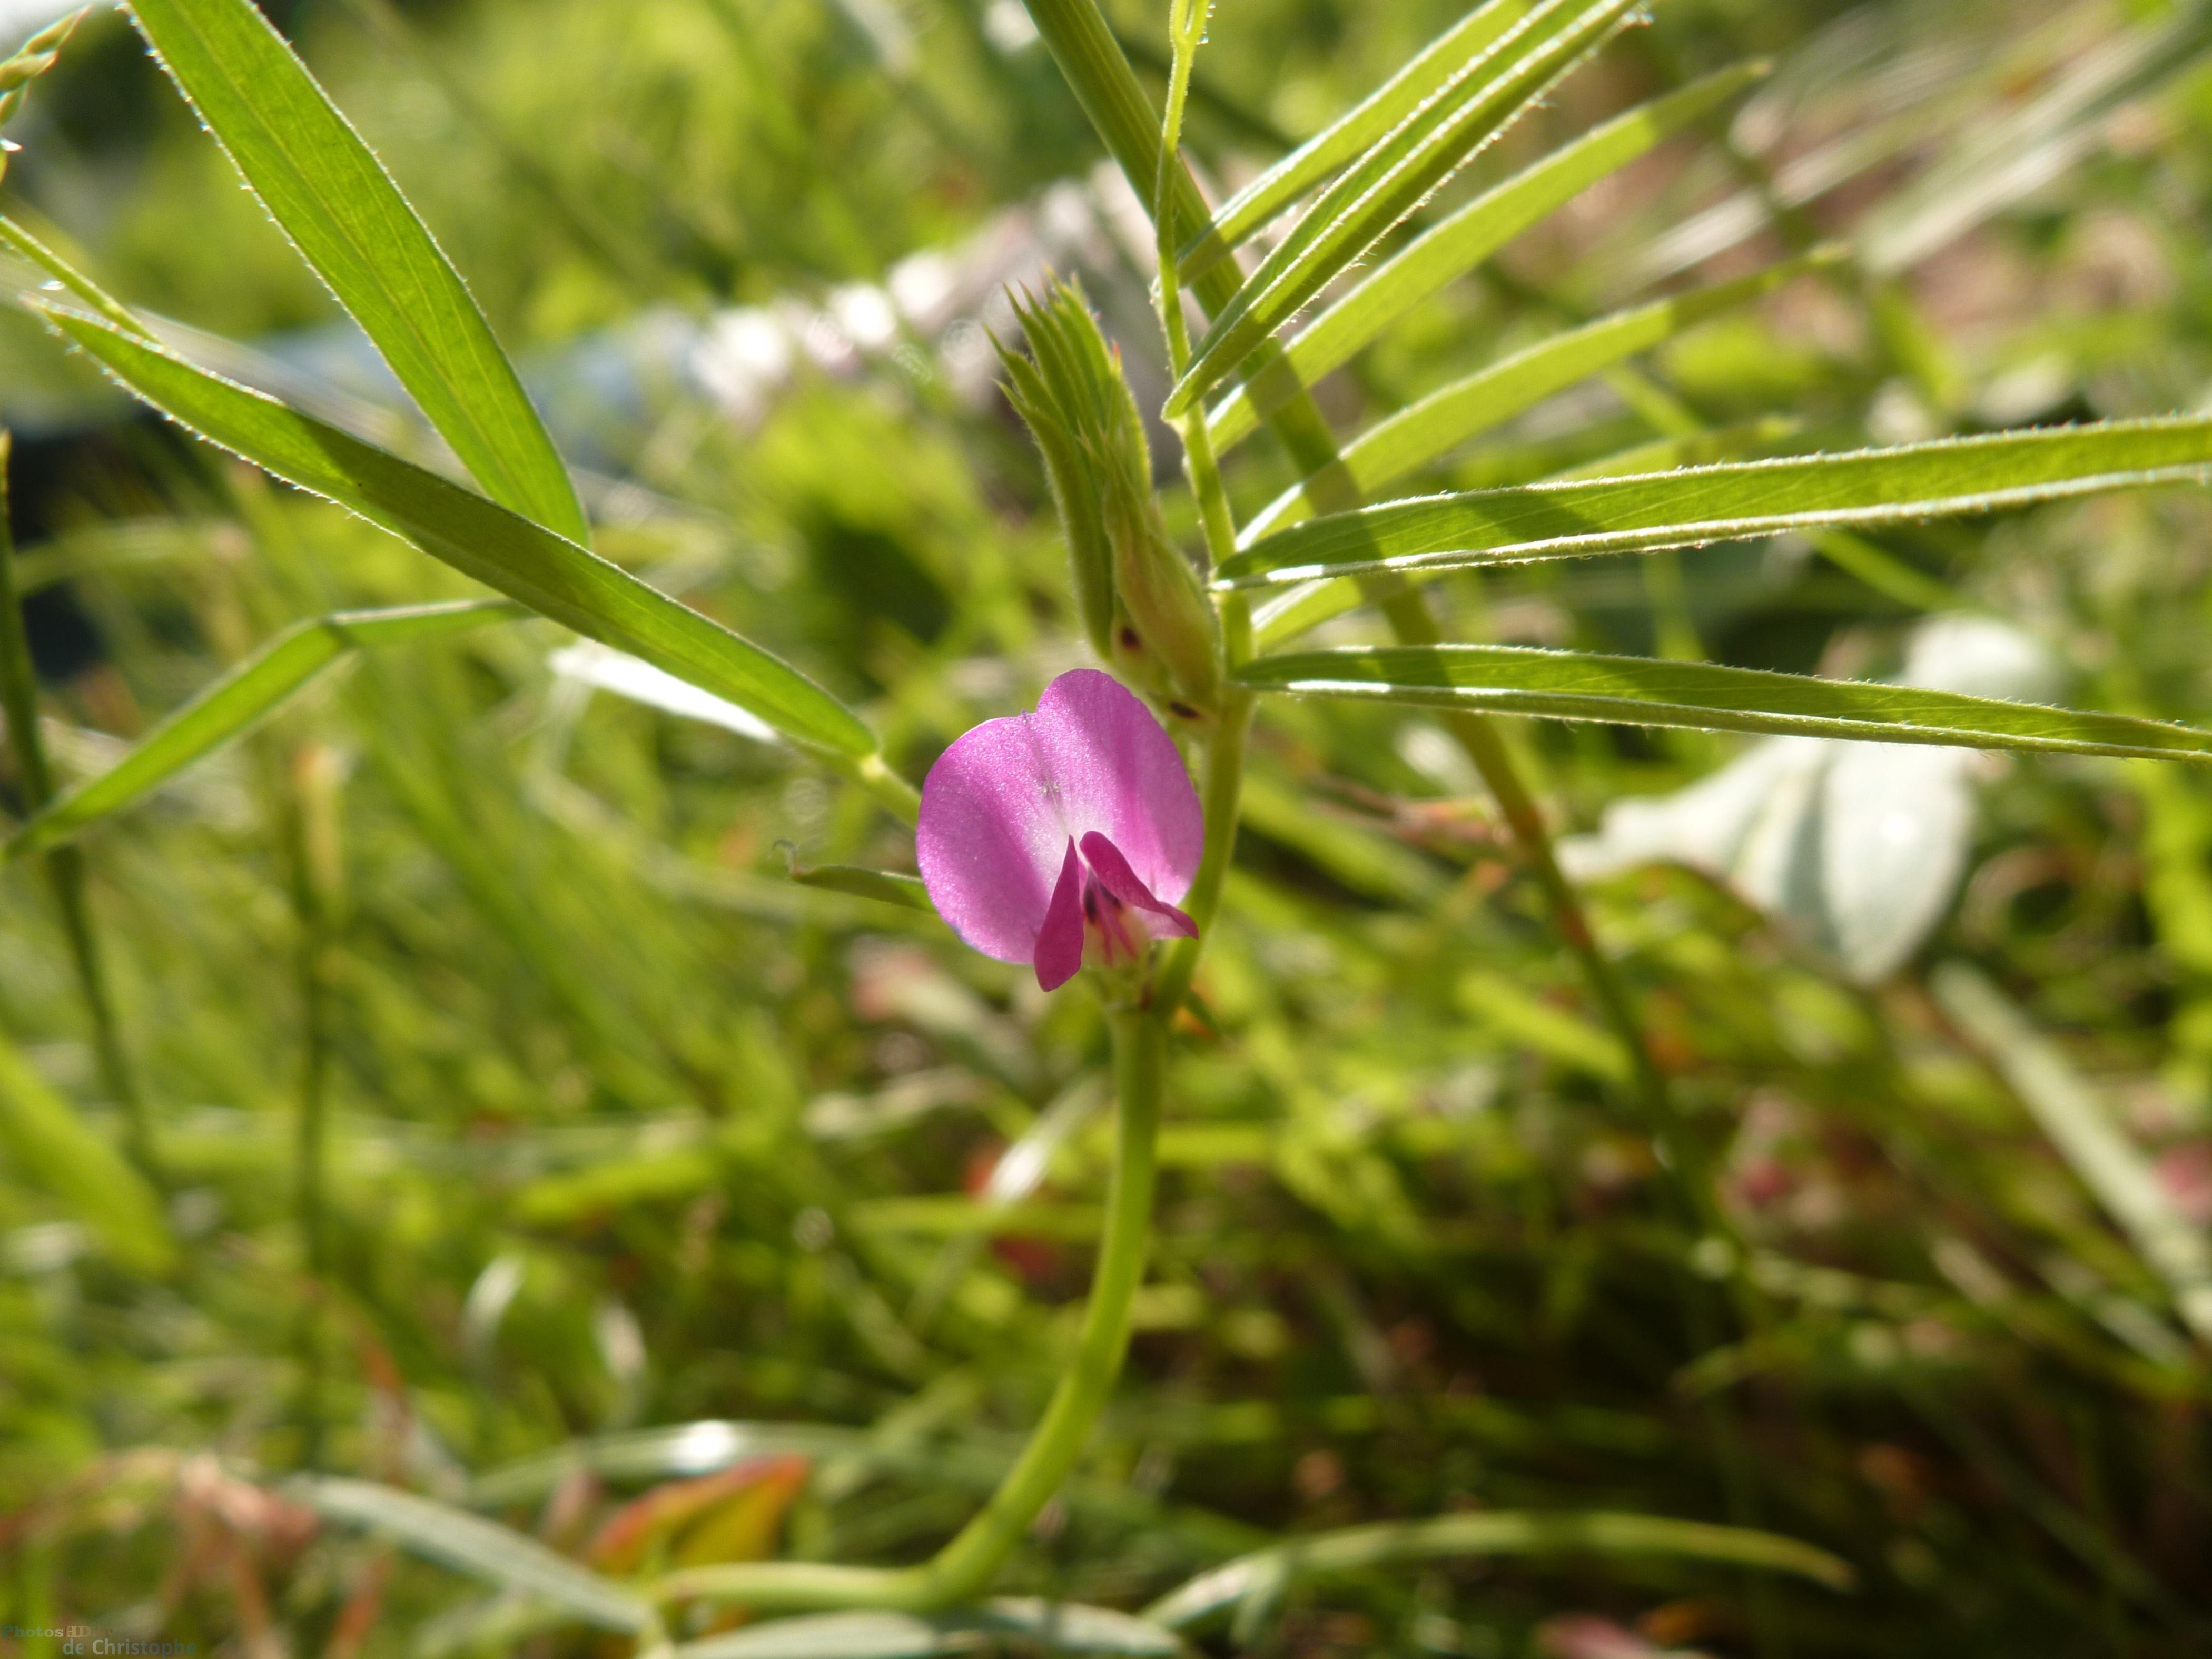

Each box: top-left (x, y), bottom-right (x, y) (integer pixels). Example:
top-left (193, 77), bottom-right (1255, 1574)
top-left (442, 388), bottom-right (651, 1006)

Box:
top-left (0, 431), bottom-right (162, 1186)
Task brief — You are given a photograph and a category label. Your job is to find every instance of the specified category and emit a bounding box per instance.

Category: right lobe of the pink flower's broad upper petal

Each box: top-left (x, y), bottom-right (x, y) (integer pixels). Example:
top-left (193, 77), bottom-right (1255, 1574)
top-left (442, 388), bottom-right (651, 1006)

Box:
top-left (1026, 668), bottom-right (1206, 905)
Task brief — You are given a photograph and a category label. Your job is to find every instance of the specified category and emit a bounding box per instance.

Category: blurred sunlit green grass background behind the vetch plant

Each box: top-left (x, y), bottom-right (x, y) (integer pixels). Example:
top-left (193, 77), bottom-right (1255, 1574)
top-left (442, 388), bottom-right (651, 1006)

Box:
top-left (0, 0), bottom-right (2212, 1659)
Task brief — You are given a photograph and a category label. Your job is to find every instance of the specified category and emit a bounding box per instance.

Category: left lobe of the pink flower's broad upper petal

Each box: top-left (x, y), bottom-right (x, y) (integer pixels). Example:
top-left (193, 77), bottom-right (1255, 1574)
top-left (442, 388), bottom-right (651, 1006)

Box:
top-left (914, 715), bottom-right (1069, 962)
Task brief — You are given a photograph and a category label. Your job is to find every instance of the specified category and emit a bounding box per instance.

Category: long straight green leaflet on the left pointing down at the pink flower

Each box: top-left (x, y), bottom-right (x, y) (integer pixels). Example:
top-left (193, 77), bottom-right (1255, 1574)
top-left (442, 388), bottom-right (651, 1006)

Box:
top-left (44, 308), bottom-right (876, 770)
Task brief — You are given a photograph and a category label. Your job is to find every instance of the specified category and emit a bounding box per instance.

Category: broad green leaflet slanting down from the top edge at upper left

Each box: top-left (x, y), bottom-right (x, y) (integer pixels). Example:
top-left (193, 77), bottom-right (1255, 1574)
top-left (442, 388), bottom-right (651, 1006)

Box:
top-left (131, 0), bottom-right (590, 542)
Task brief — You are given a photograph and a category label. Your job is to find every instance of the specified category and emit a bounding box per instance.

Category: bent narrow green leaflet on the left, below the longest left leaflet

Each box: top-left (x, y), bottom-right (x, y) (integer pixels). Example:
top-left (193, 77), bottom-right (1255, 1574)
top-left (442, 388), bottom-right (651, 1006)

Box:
top-left (0, 599), bottom-right (524, 863)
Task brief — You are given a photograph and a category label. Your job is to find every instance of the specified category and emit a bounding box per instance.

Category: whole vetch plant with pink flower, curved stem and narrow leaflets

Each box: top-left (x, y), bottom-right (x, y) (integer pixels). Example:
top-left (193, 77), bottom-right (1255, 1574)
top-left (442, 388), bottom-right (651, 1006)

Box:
top-left (13, 0), bottom-right (2212, 1659)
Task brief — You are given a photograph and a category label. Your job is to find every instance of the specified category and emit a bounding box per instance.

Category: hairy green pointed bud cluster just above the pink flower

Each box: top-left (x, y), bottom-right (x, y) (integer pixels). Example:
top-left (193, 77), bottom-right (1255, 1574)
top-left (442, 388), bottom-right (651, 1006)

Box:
top-left (1000, 283), bottom-right (1223, 723)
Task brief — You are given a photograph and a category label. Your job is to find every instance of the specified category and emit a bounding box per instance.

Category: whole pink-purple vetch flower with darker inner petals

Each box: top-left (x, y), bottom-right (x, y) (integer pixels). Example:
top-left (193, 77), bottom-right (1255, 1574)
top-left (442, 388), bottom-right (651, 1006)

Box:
top-left (914, 668), bottom-right (1206, 991)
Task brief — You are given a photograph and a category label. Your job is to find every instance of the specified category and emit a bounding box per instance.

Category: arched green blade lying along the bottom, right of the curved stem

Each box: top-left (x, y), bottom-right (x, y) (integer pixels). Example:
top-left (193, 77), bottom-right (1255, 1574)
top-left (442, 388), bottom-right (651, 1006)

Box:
top-left (1143, 1511), bottom-right (1851, 1630)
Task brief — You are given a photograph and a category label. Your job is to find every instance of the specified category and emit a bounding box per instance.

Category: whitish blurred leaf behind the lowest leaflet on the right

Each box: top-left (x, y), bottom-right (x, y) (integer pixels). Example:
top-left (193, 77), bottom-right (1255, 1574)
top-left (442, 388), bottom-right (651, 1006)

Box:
top-left (1559, 615), bottom-right (2061, 982)
